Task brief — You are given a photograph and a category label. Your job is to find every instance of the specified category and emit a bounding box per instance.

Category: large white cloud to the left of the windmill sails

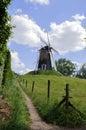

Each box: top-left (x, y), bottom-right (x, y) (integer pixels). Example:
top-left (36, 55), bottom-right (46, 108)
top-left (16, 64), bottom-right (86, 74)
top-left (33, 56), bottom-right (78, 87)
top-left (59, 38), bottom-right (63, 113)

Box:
top-left (12, 15), bottom-right (44, 47)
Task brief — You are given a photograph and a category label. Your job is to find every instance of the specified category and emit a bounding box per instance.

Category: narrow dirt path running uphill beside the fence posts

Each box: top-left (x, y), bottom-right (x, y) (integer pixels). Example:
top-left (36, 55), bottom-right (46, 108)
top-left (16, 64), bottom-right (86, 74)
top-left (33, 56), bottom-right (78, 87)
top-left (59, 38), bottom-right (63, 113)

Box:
top-left (20, 88), bottom-right (86, 130)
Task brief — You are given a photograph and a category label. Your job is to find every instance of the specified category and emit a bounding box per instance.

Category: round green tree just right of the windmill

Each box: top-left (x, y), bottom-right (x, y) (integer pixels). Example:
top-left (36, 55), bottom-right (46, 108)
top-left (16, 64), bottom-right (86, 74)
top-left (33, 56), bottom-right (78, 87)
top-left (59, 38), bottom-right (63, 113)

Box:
top-left (56, 58), bottom-right (75, 76)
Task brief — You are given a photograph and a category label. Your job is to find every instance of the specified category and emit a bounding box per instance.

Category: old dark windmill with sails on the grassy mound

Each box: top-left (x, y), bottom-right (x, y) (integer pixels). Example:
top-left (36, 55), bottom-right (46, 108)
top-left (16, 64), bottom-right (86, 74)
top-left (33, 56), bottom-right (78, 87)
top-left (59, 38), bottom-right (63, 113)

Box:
top-left (36, 33), bottom-right (58, 71)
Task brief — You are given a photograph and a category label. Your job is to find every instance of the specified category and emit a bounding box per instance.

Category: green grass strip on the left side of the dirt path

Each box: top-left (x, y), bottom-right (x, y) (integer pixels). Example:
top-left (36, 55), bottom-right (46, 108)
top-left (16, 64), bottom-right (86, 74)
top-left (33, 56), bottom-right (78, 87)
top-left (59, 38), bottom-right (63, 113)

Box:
top-left (0, 72), bottom-right (30, 130)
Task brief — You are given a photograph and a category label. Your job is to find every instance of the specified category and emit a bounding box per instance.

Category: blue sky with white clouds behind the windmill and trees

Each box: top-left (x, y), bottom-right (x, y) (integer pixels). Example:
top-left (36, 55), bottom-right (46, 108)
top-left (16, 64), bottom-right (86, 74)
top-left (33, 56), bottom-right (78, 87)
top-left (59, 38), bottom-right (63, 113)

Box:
top-left (8, 0), bottom-right (86, 74)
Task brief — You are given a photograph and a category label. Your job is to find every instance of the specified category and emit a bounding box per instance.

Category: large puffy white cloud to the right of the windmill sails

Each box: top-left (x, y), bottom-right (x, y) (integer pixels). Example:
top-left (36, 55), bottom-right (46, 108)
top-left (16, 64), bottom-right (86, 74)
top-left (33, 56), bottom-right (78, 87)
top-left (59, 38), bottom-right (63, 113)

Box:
top-left (50, 21), bottom-right (86, 53)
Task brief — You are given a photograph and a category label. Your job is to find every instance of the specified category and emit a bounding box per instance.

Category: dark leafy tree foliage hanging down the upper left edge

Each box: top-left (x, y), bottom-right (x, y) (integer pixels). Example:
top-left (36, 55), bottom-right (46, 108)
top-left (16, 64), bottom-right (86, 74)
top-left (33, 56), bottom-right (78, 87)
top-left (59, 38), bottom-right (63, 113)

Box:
top-left (0, 0), bottom-right (12, 65)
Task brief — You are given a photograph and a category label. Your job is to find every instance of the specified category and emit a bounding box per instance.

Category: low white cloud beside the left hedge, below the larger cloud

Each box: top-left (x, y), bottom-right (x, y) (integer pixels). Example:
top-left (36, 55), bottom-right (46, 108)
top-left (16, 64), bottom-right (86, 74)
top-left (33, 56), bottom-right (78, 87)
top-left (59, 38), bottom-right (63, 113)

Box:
top-left (11, 51), bottom-right (25, 70)
